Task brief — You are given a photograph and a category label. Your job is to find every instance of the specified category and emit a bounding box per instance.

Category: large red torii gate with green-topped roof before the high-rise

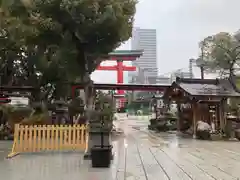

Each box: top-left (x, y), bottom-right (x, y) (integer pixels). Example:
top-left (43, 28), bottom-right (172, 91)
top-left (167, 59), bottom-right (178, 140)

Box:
top-left (97, 50), bottom-right (143, 107)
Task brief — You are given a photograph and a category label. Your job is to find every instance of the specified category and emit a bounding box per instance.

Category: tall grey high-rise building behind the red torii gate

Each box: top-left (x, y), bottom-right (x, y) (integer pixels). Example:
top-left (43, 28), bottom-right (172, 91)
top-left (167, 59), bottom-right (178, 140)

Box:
top-left (130, 28), bottom-right (158, 84)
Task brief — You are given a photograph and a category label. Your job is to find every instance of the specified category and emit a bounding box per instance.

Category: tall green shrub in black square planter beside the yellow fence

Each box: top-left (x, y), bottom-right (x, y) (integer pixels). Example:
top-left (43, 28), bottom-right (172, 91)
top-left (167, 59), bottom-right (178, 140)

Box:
top-left (89, 95), bottom-right (113, 167)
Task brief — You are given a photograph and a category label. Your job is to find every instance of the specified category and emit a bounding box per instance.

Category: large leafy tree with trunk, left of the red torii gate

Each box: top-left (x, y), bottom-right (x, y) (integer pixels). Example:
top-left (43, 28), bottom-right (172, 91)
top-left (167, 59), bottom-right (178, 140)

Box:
top-left (0, 0), bottom-right (137, 155)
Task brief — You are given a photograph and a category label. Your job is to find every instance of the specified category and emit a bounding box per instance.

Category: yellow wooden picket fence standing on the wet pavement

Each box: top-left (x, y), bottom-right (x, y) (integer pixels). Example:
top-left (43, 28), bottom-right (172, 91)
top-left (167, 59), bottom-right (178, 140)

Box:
top-left (8, 124), bottom-right (88, 158)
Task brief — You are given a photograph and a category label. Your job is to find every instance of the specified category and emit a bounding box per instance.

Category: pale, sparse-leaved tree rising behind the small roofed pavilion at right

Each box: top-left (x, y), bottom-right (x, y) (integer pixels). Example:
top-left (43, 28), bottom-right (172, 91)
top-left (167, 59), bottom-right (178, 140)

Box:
top-left (199, 32), bottom-right (240, 78)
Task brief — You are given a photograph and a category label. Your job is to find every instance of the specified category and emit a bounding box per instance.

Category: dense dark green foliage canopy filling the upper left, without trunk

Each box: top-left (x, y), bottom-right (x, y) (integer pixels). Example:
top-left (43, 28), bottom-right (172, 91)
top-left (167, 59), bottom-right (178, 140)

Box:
top-left (0, 0), bottom-right (137, 100)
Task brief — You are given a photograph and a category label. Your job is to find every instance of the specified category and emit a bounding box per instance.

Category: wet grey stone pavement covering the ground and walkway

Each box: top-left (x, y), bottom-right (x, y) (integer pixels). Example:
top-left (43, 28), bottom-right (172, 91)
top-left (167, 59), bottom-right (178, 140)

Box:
top-left (0, 117), bottom-right (240, 180)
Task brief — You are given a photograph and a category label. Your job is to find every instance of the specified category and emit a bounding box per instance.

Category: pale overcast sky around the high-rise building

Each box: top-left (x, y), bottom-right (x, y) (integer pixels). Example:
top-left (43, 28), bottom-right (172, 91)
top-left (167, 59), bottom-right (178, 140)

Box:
top-left (92, 0), bottom-right (240, 83)
